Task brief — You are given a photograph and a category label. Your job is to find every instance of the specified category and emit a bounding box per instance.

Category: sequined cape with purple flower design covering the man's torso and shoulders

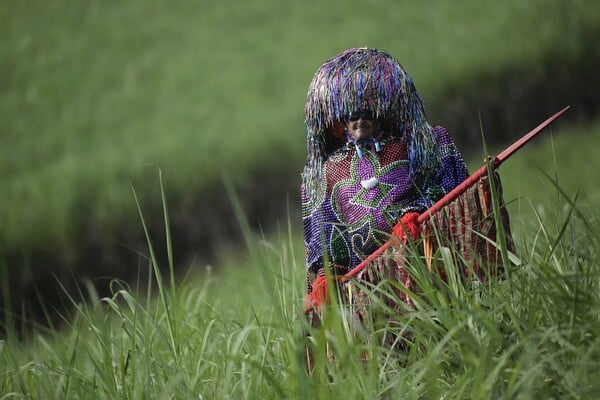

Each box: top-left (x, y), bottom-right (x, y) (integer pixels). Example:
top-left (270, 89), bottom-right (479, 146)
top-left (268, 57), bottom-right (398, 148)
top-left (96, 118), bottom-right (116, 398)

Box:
top-left (302, 127), bottom-right (467, 271)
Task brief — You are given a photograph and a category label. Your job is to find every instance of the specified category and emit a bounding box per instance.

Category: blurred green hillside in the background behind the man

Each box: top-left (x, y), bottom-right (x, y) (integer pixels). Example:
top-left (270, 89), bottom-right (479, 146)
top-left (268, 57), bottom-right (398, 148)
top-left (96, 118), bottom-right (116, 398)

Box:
top-left (0, 0), bottom-right (600, 318)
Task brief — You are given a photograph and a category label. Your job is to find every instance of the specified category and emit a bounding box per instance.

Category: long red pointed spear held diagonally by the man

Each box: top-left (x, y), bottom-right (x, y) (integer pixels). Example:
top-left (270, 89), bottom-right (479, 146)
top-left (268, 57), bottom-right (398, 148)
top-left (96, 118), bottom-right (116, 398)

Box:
top-left (342, 106), bottom-right (569, 281)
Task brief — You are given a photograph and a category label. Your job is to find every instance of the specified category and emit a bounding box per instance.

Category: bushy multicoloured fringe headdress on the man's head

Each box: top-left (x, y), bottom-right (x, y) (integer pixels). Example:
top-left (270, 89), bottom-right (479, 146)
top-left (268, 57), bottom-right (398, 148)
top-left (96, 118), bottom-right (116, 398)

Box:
top-left (302, 48), bottom-right (438, 198)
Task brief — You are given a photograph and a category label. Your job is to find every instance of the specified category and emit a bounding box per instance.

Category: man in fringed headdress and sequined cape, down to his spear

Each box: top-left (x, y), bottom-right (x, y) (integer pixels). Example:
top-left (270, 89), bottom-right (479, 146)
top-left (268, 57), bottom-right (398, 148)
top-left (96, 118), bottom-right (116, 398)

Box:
top-left (301, 48), bottom-right (468, 305)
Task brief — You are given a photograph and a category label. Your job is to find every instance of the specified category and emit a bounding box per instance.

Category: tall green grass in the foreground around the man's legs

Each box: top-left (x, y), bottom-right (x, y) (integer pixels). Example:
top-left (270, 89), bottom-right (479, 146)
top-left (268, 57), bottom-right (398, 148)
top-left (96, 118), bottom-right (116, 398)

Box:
top-left (0, 121), bottom-right (600, 399)
